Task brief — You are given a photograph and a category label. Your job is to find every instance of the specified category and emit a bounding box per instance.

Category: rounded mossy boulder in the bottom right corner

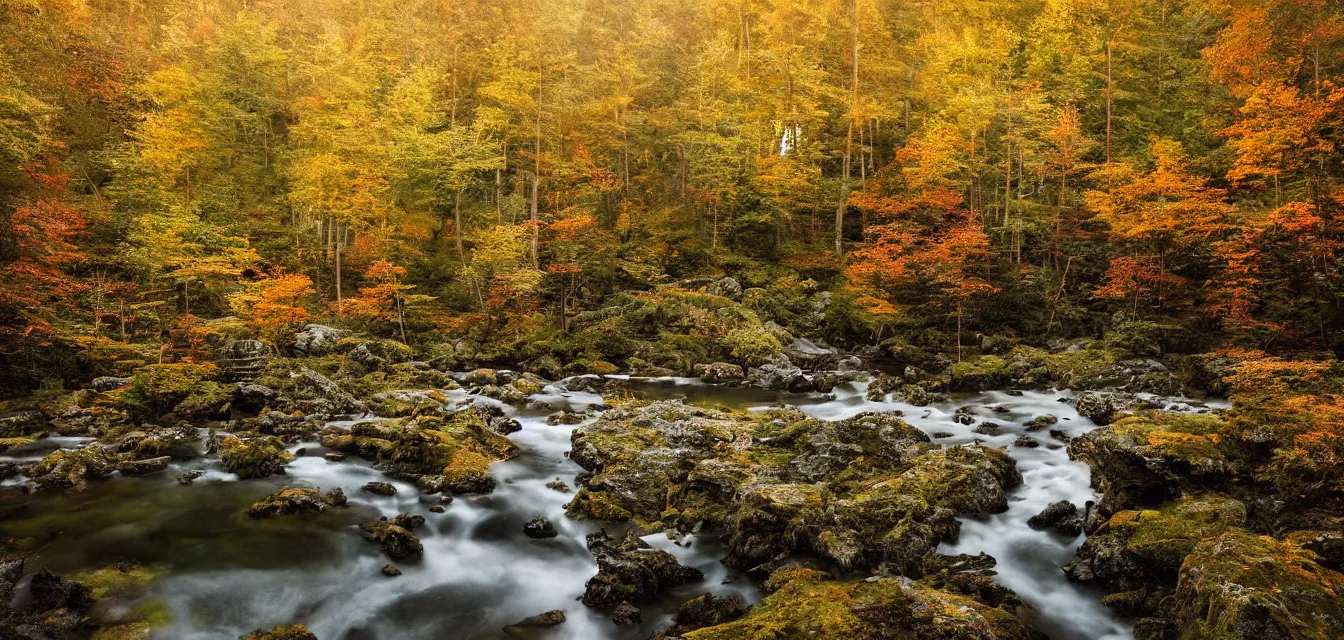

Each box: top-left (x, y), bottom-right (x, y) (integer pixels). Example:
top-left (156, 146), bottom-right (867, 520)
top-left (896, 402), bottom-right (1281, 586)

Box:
top-left (1173, 528), bottom-right (1344, 640)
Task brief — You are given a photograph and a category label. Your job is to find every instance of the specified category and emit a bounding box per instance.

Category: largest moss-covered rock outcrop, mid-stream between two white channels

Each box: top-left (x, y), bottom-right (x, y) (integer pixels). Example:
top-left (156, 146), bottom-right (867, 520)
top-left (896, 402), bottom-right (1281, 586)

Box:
top-left (567, 402), bottom-right (1021, 573)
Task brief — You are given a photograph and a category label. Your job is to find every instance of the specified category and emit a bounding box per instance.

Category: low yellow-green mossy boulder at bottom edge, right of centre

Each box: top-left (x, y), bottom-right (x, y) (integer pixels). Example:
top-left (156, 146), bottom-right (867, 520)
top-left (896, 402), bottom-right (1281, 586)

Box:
top-left (681, 570), bottom-right (1044, 640)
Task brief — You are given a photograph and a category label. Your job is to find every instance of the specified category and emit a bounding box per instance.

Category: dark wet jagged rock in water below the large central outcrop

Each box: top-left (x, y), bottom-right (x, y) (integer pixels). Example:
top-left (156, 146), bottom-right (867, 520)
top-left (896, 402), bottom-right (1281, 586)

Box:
top-left (582, 531), bottom-right (704, 608)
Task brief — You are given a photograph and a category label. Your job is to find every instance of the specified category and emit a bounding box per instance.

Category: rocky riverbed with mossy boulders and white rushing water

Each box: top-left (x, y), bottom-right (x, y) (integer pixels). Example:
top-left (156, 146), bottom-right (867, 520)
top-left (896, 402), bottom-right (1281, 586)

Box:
top-left (0, 329), bottom-right (1340, 640)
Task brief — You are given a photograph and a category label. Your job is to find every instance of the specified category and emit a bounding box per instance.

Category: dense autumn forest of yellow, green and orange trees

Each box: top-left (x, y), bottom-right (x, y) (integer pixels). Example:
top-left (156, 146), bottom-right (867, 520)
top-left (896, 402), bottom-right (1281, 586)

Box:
top-left (0, 0), bottom-right (1344, 386)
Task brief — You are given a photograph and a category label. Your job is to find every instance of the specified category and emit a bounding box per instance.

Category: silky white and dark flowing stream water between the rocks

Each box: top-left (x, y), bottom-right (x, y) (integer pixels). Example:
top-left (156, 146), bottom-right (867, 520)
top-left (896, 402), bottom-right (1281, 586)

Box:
top-left (0, 379), bottom-right (1220, 640)
